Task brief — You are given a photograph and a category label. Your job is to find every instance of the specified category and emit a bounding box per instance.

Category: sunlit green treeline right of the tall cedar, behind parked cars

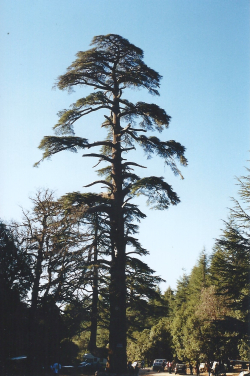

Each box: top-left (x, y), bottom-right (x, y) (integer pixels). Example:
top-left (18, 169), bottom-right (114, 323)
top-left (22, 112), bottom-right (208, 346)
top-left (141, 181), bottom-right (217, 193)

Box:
top-left (129, 171), bottom-right (250, 361)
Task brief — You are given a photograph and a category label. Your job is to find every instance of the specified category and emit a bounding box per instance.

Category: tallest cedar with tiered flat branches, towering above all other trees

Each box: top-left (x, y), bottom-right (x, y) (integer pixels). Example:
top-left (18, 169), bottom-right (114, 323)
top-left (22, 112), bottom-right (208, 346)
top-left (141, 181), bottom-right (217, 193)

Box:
top-left (36, 34), bottom-right (187, 372)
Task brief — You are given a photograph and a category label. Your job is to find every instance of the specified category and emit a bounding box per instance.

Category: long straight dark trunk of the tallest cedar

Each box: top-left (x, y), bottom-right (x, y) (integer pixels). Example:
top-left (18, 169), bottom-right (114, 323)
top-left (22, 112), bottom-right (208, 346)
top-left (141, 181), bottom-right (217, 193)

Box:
top-left (109, 94), bottom-right (127, 373)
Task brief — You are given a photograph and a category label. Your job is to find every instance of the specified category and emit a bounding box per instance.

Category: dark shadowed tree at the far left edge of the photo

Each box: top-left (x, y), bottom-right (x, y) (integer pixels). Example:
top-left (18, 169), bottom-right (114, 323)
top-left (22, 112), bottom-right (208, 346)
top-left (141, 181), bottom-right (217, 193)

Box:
top-left (0, 222), bottom-right (31, 372)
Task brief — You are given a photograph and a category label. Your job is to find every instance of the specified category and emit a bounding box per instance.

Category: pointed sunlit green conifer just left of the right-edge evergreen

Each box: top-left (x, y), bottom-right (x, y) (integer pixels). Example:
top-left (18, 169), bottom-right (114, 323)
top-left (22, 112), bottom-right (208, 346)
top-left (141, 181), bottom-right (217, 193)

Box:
top-left (172, 251), bottom-right (210, 361)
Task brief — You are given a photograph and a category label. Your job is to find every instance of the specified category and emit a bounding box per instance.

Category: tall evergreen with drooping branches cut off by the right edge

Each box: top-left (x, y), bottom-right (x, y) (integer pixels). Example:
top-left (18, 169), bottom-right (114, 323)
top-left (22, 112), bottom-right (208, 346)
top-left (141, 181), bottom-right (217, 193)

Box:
top-left (211, 170), bottom-right (250, 359)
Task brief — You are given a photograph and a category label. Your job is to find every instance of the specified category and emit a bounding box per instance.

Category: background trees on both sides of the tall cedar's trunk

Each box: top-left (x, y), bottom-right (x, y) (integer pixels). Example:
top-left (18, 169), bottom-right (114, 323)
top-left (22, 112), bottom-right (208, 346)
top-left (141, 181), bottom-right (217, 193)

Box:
top-left (0, 171), bottom-right (250, 366)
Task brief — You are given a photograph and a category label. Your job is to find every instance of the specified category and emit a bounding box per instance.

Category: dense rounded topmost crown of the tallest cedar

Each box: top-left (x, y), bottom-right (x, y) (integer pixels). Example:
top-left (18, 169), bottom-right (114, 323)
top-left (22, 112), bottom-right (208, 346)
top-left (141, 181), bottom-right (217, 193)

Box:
top-left (56, 34), bottom-right (161, 96)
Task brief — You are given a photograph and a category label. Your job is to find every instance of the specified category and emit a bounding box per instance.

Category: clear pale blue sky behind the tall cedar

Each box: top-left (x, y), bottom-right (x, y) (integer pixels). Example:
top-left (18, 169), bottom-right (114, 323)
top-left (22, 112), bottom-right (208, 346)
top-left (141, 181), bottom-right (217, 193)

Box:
top-left (0, 0), bottom-right (250, 289)
